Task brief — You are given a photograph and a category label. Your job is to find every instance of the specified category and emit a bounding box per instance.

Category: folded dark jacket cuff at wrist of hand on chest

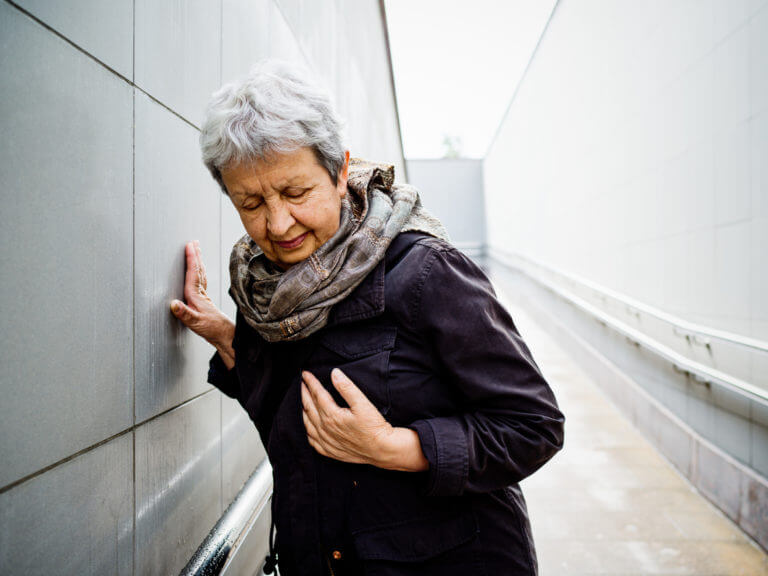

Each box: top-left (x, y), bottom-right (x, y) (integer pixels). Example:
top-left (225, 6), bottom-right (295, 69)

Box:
top-left (407, 417), bottom-right (469, 496)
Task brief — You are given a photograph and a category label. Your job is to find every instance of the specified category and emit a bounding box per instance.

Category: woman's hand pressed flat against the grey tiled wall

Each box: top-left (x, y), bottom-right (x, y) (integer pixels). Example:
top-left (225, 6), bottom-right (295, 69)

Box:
top-left (171, 240), bottom-right (235, 369)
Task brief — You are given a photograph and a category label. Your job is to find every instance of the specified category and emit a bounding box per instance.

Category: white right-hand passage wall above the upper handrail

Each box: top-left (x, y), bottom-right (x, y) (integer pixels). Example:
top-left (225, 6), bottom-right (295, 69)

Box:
top-left (485, 0), bottom-right (768, 340)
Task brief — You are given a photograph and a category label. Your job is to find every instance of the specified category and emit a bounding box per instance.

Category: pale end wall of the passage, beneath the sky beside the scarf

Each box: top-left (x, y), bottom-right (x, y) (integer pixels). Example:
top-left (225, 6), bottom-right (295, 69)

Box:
top-left (407, 158), bottom-right (485, 257)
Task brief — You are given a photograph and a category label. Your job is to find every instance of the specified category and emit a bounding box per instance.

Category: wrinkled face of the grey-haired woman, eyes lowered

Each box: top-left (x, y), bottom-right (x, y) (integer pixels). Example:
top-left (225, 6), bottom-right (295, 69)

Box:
top-left (221, 148), bottom-right (349, 269)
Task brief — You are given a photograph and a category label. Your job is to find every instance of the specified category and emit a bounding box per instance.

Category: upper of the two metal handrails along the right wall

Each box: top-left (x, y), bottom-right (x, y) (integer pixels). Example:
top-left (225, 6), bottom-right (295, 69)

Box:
top-left (500, 249), bottom-right (768, 353)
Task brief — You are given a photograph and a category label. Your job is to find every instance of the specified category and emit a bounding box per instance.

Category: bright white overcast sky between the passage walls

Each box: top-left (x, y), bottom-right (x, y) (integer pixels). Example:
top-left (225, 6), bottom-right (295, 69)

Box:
top-left (386, 0), bottom-right (555, 158)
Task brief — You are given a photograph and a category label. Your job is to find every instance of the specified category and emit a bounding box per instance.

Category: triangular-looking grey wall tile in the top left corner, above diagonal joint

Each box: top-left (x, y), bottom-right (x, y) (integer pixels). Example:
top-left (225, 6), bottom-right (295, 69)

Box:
top-left (12, 0), bottom-right (133, 78)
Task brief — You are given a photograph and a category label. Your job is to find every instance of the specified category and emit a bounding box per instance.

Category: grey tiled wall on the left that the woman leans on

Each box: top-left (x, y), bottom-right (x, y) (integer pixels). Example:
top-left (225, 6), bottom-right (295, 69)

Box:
top-left (0, 0), bottom-right (403, 575)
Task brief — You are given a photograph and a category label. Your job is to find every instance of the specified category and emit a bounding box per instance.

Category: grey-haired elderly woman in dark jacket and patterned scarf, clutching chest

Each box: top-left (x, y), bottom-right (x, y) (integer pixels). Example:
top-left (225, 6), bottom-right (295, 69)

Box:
top-left (172, 63), bottom-right (564, 576)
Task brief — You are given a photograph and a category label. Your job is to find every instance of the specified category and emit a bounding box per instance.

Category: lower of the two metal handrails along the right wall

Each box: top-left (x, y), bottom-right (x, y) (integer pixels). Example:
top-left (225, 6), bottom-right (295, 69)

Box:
top-left (489, 251), bottom-right (768, 406)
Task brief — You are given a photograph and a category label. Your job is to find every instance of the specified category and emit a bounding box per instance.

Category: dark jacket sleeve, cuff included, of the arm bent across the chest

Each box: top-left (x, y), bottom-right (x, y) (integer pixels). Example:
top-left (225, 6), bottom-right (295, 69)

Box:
top-left (409, 247), bottom-right (565, 496)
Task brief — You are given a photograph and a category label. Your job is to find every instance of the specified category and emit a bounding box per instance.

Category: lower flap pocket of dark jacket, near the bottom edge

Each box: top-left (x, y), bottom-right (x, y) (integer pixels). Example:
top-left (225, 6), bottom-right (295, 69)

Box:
top-left (352, 512), bottom-right (478, 562)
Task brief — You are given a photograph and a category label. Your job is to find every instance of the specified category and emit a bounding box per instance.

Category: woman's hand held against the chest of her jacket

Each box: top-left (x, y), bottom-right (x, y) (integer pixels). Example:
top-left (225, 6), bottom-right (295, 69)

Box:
top-left (301, 368), bottom-right (429, 472)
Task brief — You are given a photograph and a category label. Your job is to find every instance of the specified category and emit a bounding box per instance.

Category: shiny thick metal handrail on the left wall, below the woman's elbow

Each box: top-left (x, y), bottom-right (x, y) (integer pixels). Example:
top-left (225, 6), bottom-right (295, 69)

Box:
top-left (180, 458), bottom-right (272, 576)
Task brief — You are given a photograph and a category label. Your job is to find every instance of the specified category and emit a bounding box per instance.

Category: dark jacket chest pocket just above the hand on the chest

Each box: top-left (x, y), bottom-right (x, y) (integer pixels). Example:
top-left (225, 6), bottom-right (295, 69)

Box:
top-left (313, 325), bottom-right (397, 414)
